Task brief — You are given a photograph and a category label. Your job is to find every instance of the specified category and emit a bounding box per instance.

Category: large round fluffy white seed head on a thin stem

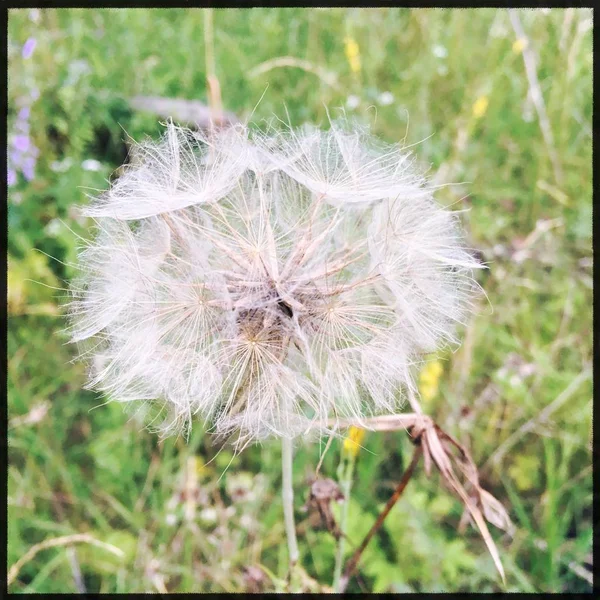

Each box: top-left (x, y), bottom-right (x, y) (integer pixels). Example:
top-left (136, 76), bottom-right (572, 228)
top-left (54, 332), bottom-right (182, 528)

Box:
top-left (70, 123), bottom-right (480, 440)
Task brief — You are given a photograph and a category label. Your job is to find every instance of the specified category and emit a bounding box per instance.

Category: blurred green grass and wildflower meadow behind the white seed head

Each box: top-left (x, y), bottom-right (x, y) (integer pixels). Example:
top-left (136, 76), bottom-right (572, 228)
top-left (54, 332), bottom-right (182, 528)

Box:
top-left (8, 8), bottom-right (592, 593)
